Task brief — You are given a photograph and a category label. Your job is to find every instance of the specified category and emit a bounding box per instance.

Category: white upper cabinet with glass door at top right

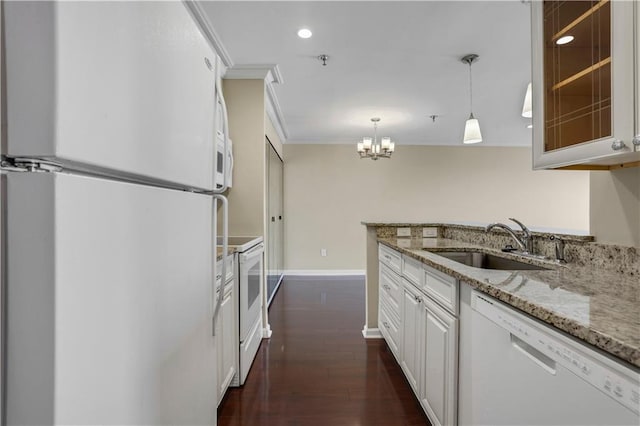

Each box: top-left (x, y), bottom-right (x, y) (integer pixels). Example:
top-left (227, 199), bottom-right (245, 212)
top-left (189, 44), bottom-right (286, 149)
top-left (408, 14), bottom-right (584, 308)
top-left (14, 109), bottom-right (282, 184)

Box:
top-left (532, 0), bottom-right (640, 169)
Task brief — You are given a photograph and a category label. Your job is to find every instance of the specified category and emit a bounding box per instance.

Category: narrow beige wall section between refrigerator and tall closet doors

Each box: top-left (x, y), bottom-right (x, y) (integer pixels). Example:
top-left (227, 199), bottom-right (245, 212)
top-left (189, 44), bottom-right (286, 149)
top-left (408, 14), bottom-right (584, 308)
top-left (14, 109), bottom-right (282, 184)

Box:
top-left (223, 79), bottom-right (265, 235)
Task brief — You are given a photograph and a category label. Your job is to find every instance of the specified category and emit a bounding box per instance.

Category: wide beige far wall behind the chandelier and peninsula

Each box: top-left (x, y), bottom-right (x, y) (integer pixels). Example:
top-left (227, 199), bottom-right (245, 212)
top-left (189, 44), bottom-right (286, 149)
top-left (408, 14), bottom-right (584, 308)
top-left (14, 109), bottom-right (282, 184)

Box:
top-left (284, 144), bottom-right (589, 270)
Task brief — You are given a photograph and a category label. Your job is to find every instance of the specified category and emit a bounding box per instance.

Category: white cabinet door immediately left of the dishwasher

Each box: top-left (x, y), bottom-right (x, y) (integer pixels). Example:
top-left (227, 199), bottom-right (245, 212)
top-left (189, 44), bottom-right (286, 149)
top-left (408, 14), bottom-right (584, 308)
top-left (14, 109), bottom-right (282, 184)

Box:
top-left (419, 298), bottom-right (458, 426)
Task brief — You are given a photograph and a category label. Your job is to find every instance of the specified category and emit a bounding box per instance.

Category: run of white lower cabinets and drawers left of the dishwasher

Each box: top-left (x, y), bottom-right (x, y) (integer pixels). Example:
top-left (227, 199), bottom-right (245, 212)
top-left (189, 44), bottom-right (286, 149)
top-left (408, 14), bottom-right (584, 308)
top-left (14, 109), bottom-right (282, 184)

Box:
top-left (378, 246), bottom-right (459, 426)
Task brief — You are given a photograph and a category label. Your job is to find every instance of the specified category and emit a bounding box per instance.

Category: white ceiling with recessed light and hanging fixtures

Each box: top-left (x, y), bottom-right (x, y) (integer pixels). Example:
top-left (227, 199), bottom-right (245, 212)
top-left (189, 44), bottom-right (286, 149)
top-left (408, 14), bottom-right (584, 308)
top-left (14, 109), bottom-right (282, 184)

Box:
top-left (202, 0), bottom-right (531, 146)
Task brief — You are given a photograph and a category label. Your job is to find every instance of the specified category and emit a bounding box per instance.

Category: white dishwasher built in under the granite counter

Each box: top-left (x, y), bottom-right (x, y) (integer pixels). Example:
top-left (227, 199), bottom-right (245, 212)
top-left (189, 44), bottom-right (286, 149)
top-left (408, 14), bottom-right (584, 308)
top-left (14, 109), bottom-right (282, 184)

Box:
top-left (459, 285), bottom-right (640, 426)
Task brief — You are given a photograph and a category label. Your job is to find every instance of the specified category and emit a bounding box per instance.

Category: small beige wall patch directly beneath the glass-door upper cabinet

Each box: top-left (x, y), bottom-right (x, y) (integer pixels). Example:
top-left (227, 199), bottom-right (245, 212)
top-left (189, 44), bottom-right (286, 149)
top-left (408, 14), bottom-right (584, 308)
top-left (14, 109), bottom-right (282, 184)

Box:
top-left (590, 167), bottom-right (640, 247)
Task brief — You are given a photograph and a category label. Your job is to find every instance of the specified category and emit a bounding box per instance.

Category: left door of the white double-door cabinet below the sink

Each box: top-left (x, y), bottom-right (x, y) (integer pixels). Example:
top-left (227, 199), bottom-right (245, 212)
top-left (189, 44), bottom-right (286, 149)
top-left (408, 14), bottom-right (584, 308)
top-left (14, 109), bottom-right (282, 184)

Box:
top-left (400, 278), bottom-right (424, 394)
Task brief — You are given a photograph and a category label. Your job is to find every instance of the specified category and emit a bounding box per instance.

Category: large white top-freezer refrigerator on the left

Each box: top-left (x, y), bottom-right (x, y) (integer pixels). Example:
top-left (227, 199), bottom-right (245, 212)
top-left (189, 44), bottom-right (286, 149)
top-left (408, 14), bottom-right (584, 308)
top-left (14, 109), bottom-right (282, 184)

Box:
top-left (0, 1), bottom-right (228, 425)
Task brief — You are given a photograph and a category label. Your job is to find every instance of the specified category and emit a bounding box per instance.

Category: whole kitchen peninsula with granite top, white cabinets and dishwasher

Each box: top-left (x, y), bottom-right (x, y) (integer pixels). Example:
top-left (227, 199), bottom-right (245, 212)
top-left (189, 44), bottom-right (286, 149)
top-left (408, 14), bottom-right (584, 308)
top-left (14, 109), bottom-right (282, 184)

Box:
top-left (363, 222), bottom-right (640, 424)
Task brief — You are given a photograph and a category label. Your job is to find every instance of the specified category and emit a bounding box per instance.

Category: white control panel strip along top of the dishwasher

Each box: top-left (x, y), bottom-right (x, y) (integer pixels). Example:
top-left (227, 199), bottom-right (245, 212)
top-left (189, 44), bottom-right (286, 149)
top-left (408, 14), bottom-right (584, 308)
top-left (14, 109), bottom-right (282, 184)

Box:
top-left (471, 291), bottom-right (640, 414)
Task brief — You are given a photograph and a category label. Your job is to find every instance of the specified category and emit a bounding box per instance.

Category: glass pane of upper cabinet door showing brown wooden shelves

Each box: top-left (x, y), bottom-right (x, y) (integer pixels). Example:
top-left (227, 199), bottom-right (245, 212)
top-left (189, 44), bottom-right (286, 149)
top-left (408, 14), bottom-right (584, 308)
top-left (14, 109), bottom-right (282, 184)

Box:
top-left (543, 0), bottom-right (612, 151)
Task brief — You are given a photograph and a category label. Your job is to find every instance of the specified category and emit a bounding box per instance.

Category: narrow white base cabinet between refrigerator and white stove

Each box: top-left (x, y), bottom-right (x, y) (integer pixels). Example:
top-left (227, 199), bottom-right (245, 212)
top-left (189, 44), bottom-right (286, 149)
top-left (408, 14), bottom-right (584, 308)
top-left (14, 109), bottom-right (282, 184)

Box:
top-left (215, 255), bottom-right (239, 404)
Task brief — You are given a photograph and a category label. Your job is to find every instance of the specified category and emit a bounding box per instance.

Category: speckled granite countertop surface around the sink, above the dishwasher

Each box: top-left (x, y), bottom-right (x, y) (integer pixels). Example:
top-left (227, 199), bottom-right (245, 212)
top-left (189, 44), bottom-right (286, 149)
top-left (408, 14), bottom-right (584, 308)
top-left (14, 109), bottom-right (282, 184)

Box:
top-left (378, 238), bottom-right (640, 367)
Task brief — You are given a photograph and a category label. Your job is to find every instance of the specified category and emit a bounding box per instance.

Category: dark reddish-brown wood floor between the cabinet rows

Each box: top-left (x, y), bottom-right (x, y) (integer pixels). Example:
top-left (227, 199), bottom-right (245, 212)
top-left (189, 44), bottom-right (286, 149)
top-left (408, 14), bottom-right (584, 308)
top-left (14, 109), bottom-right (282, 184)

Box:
top-left (218, 277), bottom-right (429, 426)
